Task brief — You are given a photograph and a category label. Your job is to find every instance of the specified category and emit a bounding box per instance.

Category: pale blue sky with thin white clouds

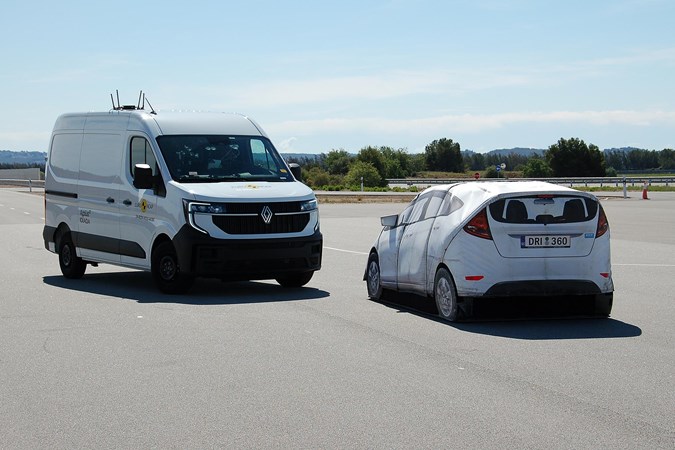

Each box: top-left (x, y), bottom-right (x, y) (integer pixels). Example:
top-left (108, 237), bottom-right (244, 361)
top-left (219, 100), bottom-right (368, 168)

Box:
top-left (0, 0), bottom-right (675, 153)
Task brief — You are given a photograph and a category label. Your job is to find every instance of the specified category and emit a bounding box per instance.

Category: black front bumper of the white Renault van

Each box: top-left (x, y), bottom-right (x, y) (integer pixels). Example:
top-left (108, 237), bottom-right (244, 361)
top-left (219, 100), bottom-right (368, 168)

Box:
top-left (173, 226), bottom-right (323, 281)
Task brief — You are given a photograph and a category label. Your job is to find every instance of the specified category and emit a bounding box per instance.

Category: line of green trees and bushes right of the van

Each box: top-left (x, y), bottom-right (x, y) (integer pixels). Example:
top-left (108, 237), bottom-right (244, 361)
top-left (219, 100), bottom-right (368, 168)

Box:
top-left (289, 138), bottom-right (675, 190)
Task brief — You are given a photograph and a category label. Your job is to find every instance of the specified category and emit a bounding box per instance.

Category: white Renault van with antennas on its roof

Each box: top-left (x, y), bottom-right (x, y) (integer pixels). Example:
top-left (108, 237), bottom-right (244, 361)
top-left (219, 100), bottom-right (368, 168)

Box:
top-left (43, 105), bottom-right (323, 294)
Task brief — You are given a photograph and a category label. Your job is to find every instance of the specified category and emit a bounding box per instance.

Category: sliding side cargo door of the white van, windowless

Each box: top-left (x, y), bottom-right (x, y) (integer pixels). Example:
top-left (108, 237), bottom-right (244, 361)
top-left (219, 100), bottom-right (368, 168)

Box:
top-left (77, 133), bottom-right (123, 263)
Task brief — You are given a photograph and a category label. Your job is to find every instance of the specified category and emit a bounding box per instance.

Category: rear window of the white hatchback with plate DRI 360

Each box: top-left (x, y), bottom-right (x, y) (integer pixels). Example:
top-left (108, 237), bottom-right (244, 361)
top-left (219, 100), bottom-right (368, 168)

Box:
top-left (490, 195), bottom-right (598, 224)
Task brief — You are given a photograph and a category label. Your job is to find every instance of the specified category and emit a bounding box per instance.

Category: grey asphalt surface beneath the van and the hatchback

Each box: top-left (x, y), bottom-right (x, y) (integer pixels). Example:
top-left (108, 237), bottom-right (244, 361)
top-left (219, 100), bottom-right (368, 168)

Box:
top-left (0, 188), bottom-right (675, 449)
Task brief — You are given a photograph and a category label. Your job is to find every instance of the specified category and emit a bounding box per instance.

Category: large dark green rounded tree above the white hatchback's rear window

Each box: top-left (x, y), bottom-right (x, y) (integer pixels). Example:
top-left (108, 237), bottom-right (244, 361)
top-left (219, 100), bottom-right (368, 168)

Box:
top-left (546, 138), bottom-right (605, 177)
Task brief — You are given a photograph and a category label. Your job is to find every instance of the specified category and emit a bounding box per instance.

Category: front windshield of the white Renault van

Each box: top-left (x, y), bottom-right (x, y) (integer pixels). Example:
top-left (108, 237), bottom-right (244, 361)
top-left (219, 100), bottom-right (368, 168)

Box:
top-left (157, 135), bottom-right (294, 183)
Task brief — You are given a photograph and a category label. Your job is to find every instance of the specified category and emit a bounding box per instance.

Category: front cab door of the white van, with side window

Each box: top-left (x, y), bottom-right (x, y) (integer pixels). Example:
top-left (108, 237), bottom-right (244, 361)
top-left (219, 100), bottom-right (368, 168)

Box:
top-left (120, 136), bottom-right (161, 269)
